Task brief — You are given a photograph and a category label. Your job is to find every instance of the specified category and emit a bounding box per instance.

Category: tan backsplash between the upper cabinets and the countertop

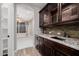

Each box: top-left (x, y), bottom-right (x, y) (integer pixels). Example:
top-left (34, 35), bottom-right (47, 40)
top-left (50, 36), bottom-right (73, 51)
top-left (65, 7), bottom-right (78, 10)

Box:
top-left (44, 25), bottom-right (79, 38)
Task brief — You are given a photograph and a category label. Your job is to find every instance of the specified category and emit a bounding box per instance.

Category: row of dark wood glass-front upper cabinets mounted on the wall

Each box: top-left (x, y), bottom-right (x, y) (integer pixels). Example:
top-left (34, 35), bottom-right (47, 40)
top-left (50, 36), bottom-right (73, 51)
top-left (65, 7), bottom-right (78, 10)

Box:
top-left (39, 3), bottom-right (79, 27)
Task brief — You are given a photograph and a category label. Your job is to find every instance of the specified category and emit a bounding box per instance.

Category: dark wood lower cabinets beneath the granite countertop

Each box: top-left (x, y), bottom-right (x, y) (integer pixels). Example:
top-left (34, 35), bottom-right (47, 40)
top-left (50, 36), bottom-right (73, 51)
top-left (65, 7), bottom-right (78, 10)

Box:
top-left (35, 36), bottom-right (79, 56)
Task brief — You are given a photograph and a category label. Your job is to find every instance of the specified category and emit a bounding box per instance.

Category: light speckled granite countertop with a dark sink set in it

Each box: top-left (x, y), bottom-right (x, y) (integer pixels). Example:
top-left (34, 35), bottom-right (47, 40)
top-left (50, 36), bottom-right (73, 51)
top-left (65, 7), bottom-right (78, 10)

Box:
top-left (36, 34), bottom-right (79, 50)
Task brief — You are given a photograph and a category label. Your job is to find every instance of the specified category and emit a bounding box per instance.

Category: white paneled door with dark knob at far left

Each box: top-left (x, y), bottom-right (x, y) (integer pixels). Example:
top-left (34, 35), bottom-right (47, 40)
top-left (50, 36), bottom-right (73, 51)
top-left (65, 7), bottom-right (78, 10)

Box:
top-left (0, 3), bottom-right (15, 56)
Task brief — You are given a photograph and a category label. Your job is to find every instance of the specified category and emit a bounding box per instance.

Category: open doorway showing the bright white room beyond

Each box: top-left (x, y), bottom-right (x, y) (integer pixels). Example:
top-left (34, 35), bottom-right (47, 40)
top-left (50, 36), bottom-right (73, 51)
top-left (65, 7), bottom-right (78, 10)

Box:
top-left (16, 3), bottom-right (34, 51)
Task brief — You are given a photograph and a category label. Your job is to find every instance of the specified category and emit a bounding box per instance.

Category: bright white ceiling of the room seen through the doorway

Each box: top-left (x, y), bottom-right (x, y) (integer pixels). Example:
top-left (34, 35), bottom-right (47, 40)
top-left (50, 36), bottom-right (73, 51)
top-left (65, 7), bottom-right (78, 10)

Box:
top-left (16, 4), bottom-right (34, 20)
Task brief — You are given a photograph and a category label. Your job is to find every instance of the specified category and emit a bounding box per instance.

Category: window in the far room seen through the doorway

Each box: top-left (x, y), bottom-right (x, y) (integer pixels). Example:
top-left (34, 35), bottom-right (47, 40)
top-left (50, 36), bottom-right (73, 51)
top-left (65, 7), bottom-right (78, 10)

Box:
top-left (17, 17), bottom-right (29, 33)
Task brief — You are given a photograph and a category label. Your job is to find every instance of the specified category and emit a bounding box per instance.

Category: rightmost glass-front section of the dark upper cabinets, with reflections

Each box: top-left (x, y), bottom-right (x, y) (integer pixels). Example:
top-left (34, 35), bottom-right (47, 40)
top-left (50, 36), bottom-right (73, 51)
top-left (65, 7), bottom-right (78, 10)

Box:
top-left (62, 3), bottom-right (79, 21)
